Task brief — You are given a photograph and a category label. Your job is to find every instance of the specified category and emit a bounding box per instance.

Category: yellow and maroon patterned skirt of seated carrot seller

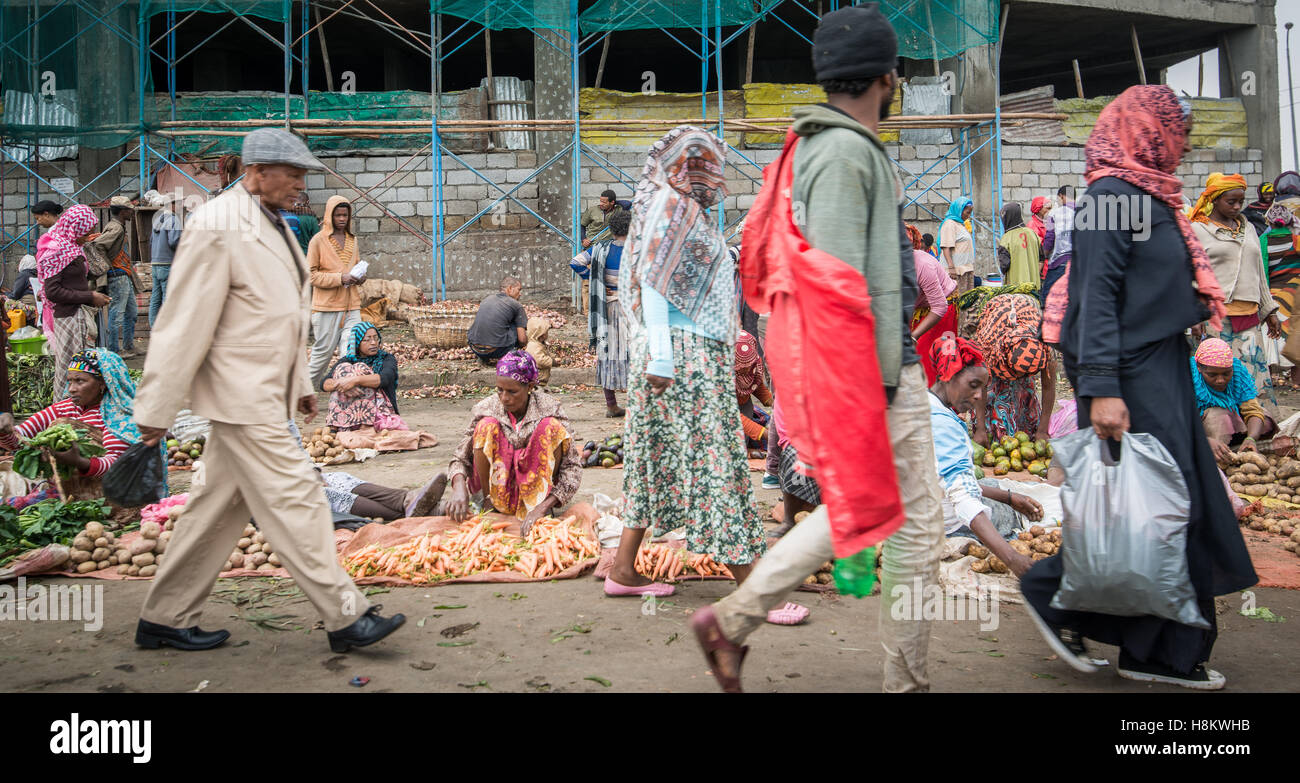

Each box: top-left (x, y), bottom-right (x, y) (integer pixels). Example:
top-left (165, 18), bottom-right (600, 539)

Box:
top-left (469, 416), bottom-right (572, 519)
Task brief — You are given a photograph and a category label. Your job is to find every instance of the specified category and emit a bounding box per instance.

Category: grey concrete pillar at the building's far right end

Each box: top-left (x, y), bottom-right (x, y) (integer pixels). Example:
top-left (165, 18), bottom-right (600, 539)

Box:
top-left (1219, 17), bottom-right (1279, 176)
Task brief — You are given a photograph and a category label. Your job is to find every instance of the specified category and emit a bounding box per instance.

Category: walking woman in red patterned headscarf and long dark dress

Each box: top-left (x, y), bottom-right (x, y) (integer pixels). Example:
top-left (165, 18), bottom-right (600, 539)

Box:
top-left (1021, 85), bottom-right (1258, 689)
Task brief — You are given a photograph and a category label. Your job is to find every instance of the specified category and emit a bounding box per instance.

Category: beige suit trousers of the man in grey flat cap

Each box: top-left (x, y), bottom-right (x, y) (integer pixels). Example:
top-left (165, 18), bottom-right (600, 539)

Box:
top-left (140, 421), bottom-right (369, 631)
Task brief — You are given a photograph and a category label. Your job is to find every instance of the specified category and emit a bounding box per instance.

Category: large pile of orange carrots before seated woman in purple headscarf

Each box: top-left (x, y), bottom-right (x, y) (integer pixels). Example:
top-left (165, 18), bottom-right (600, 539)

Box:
top-left (343, 516), bottom-right (601, 584)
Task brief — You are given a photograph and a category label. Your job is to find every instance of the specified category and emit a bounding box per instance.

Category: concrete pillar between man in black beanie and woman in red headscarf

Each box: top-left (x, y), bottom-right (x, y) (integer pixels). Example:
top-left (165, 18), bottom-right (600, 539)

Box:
top-left (944, 44), bottom-right (998, 274)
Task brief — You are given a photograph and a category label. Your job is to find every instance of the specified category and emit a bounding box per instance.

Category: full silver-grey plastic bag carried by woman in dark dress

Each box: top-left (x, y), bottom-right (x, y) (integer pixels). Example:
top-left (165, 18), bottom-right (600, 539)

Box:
top-left (1052, 428), bottom-right (1209, 628)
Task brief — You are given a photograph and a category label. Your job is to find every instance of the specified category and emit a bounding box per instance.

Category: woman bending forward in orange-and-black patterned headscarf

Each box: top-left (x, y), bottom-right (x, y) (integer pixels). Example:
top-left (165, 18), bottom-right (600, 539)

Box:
top-left (974, 294), bottom-right (1056, 446)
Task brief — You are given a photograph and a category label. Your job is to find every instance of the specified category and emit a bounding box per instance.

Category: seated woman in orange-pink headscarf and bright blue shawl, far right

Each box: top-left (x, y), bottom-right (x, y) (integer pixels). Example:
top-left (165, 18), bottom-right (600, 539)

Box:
top-left (1191, 337), bottom-right (1278, 460)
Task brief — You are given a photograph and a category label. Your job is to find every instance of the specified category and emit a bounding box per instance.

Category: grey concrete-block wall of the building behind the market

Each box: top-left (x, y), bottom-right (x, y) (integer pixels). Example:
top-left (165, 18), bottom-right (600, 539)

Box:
top-left (0, 144), bottom-right (1262, 295)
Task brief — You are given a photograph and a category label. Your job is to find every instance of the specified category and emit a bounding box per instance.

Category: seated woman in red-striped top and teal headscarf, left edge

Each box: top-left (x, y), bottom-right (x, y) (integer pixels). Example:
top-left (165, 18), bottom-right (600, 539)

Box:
top-left (0, 349), bottom-right (140, 507)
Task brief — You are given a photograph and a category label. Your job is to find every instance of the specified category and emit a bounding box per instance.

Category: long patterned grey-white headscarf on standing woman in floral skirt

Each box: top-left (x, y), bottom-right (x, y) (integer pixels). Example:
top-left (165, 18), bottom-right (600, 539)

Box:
top-left (619, 125), bottom-right (737, 343)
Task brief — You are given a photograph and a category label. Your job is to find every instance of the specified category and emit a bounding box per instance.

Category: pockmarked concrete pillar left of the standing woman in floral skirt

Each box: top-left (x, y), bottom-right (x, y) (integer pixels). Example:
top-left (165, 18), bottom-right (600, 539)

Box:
top-left (533, 30), bottom-right (577, 233)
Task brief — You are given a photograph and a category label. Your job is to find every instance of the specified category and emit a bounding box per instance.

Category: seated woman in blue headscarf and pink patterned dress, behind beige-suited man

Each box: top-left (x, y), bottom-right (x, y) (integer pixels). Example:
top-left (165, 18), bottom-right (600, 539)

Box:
top-left (321, 321), bottom-right (407, 431)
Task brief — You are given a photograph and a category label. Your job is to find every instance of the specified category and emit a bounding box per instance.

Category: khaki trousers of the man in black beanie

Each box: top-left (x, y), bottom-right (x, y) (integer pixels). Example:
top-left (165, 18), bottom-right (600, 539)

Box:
top-left (714, 364), bottom-right (944, 693)
